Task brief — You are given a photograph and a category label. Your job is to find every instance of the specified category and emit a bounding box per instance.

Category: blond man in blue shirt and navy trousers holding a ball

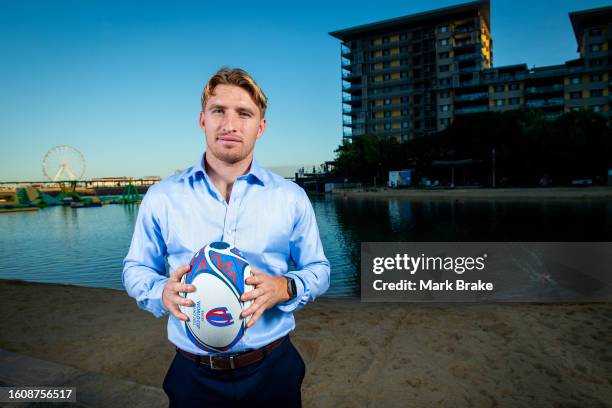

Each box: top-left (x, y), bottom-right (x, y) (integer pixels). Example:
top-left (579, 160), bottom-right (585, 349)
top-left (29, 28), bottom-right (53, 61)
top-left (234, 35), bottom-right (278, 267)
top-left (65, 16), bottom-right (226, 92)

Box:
top-left (123, 68), bottom-right (330, 407)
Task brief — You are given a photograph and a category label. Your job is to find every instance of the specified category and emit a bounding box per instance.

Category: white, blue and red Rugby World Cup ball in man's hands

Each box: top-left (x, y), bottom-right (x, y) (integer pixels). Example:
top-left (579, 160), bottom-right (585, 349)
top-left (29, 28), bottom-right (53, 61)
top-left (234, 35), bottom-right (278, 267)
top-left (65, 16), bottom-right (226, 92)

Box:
top-left (179, 242), bottom-right (253, 353)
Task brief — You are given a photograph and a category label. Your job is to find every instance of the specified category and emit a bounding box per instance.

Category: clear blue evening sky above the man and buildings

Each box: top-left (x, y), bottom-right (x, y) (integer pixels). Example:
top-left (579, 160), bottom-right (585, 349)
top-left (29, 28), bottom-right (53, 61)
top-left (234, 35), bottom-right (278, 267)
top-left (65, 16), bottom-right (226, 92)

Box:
top-left (0, 0), bottom-right (610, 181)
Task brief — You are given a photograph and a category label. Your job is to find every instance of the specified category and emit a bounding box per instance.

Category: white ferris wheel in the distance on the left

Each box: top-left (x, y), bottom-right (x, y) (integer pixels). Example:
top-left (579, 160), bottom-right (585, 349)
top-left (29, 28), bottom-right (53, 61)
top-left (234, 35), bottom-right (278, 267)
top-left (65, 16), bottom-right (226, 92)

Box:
top-left (42, 145), bottom-right (87, 181)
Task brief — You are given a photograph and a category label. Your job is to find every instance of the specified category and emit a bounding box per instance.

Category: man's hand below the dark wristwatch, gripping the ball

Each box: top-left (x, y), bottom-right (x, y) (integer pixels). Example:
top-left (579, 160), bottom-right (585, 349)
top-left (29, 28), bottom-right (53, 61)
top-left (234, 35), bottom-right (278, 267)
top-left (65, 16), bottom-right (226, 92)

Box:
top-left (240, 268), bottom-right (289, 328)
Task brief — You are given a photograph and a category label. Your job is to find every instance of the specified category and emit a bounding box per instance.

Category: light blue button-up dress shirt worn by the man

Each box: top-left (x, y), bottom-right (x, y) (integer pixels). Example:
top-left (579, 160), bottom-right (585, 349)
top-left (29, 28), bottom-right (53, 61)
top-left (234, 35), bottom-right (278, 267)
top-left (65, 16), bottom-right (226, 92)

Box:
top-left (123, 155), bottom-right (330, 354)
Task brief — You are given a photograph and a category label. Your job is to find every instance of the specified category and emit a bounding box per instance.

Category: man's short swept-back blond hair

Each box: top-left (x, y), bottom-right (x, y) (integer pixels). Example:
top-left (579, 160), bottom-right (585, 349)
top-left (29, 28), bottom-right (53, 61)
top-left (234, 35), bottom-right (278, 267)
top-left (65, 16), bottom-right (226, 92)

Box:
top-left (201, 67), bottom-right (268, 118)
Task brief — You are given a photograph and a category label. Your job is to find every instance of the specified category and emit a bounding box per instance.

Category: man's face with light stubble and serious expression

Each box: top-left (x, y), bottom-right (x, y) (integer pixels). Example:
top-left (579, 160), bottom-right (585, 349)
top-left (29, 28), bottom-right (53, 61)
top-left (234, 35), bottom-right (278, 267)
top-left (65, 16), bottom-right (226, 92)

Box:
top-left (200, 85), bottom-right (266, 164)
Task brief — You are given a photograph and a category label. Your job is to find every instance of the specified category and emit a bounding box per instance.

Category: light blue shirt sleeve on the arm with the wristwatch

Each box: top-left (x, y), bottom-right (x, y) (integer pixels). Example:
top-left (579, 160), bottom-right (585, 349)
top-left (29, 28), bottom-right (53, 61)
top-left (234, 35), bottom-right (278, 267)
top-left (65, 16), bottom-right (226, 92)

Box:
top-left (277, 189), bottom-right (330, 312)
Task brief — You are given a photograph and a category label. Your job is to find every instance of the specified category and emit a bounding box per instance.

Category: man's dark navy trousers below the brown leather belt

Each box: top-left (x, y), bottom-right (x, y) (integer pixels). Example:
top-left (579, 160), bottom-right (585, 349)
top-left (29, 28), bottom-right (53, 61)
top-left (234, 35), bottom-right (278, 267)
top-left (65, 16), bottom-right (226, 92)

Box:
top-left (164, 337), bottom-right (306, 408)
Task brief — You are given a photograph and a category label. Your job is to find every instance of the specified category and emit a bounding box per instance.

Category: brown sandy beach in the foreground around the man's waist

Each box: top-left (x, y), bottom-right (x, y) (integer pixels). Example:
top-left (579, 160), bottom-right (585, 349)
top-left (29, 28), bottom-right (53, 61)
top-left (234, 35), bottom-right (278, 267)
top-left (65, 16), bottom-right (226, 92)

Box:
top-left (0, 281), bottom-right (612, 407)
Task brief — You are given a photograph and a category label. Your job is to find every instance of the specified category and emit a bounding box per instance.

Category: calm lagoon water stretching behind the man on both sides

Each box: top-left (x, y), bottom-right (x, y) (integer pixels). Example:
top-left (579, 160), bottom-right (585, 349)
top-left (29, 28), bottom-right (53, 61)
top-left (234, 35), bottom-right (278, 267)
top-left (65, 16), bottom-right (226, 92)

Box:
top-left (0, 193), bottom-right (612, 297)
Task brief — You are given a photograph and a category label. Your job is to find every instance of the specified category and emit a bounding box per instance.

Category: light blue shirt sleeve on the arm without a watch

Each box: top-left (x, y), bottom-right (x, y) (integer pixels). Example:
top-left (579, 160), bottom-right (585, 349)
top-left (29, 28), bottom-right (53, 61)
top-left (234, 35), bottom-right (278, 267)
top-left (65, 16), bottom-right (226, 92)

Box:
top-left (122, 189), bottom-right (168, 317)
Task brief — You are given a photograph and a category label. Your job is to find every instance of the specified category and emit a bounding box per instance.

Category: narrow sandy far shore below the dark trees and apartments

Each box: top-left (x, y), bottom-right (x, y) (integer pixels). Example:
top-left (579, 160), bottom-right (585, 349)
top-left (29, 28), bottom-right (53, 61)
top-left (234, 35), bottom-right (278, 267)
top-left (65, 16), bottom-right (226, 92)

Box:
top-left (331, 186), bottom-right (612, 200)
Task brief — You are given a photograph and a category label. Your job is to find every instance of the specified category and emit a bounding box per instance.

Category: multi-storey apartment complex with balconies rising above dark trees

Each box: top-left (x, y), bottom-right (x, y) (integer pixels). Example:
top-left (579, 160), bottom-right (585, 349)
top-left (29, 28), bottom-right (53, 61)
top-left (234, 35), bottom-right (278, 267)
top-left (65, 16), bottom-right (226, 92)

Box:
top-left (330, 0), bottom-right (612, 141)
